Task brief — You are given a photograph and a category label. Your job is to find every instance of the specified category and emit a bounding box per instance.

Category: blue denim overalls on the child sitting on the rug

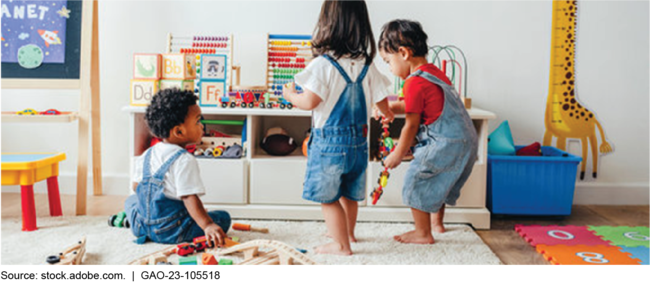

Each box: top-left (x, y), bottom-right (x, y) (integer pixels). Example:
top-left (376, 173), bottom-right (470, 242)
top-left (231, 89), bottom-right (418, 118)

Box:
top-left (124, 149), bottom-right (231, 244)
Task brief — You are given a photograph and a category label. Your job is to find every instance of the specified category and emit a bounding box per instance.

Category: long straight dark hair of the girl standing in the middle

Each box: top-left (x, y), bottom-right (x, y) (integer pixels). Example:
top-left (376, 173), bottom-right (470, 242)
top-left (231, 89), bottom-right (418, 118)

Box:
top-left (312, 0), bottom-right (377, 61)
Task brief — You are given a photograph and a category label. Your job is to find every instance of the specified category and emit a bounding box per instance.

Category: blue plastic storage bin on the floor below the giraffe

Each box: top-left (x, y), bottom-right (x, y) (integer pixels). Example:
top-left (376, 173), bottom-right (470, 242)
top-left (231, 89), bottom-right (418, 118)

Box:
top-left (487, 147), bottom-right (582, 216)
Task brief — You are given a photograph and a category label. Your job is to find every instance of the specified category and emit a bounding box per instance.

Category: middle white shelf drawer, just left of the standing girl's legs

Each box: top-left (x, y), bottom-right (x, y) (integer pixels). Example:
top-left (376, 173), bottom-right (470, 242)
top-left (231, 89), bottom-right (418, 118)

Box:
top-left (250, 157), bottom-right (315, 205)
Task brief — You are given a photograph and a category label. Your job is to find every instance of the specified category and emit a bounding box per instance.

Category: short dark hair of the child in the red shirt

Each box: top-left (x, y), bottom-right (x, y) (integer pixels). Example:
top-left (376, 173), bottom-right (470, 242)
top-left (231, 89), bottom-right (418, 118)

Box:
top-left (379, 20), bottom-right (429, 57)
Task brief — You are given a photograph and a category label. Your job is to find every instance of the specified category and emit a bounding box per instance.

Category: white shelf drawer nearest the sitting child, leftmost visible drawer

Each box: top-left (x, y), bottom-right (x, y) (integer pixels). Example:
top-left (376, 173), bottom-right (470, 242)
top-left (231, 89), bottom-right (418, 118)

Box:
top-left (197, 158), bottom-right (248, 204)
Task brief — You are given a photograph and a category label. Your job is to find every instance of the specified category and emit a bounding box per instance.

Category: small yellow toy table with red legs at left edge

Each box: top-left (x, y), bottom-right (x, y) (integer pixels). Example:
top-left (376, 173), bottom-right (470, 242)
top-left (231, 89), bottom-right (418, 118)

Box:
top-left (0, 153), bottom-right (65, 231)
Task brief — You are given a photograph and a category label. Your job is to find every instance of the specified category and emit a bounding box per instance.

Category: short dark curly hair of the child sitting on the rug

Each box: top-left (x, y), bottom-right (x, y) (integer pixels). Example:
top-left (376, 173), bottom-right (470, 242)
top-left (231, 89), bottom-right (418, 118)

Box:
top-left (145, 88), bottom-right (198, 139)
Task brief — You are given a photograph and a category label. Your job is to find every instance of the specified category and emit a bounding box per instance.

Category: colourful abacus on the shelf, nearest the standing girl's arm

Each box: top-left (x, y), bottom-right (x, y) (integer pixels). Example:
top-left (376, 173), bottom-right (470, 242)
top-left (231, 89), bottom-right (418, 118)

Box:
top-left (266, 34), bottom-right (313, 97)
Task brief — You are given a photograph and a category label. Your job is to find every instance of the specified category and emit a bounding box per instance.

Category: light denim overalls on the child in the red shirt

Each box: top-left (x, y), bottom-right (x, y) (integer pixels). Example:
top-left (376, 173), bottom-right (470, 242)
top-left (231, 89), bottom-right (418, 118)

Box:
top-left (402, 70), bottom-right (478, 213)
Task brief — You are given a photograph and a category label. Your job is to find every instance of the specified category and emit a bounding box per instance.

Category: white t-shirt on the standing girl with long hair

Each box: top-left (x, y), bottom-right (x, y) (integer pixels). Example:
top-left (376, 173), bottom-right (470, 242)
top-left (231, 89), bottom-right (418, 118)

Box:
top-left (295, 56), bottom-right (392, 129)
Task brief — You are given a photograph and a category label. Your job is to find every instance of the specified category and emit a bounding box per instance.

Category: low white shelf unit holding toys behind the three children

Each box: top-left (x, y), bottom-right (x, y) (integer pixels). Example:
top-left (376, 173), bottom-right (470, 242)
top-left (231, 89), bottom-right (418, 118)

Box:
top-left (123, 107), bottom-right (496, 229)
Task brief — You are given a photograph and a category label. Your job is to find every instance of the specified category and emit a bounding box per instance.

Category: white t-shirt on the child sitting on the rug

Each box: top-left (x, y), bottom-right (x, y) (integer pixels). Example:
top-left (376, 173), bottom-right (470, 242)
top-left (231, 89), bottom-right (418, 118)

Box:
top-left (131, 142), bottom-right (205, 200)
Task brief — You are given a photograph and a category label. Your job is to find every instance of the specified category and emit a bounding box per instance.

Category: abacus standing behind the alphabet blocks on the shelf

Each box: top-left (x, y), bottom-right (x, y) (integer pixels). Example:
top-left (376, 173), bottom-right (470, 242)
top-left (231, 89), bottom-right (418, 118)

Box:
top-left (167, 33), bottom-right (240, 89)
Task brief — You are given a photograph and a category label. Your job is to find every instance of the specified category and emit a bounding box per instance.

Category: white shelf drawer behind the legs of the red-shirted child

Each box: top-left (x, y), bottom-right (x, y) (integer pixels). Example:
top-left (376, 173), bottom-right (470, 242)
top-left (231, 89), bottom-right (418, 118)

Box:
top-left (368, 162), bottom-right (487, 208)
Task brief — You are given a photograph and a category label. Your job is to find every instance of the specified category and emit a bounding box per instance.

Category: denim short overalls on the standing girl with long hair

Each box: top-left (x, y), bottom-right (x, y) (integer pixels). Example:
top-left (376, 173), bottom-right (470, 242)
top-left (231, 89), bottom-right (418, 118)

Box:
top-left (303, 55), bottom-right (370, 204)
